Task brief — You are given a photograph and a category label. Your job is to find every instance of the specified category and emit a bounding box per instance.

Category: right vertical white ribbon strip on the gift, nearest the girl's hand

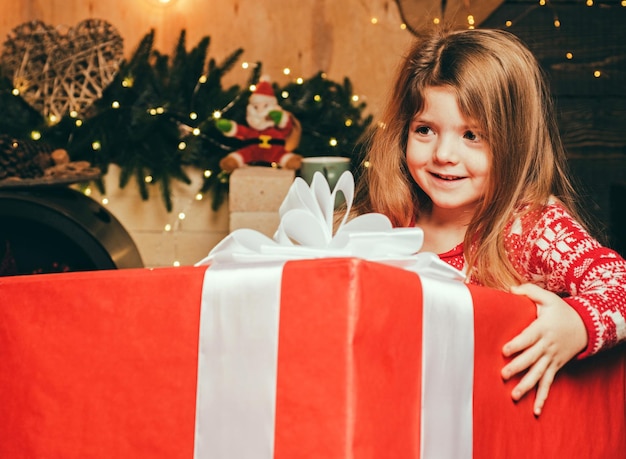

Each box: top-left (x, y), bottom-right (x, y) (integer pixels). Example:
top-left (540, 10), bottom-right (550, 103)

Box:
top-left (420, 276), bottom-right (474, 459)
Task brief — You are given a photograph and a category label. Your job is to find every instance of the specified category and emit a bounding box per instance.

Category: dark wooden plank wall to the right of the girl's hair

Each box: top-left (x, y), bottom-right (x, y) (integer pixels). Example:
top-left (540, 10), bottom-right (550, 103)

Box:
top-left (481, 0), bottom-right (626, 254)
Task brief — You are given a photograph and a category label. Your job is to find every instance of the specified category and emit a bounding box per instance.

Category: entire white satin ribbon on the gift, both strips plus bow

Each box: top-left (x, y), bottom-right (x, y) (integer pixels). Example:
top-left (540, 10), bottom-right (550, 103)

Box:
top-left (194, 172), bottom-right (473, 459)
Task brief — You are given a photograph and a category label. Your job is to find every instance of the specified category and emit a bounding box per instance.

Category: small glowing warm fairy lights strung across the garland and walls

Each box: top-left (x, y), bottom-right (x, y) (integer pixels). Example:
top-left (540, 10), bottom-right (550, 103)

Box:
top-left (33, 0), bottom-right (626, 266)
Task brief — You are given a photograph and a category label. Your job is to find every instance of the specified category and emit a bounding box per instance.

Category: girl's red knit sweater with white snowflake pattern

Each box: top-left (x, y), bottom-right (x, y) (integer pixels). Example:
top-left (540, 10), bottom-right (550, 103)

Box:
top-left (440, 203), bottom-right (626, 358)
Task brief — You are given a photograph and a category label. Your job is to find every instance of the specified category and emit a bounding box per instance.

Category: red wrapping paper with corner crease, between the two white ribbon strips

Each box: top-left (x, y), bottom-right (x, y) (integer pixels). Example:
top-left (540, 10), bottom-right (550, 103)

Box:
top-left (275, 260), bottom-right (422, 459)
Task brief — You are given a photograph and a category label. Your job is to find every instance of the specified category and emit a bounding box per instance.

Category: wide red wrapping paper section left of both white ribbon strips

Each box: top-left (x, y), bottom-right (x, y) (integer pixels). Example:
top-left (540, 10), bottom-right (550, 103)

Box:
top-left (0, 268), bottom-right (204, 459)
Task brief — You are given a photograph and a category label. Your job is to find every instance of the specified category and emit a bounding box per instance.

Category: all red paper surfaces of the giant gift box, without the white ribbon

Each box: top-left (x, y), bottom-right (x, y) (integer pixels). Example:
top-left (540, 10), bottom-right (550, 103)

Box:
top-left (0, 259), bottom-right (626, 459)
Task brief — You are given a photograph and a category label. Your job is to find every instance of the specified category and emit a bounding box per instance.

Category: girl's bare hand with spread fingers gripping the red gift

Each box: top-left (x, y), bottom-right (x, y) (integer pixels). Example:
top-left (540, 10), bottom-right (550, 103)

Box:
top-left (502, 284), bottom-right (588, 416)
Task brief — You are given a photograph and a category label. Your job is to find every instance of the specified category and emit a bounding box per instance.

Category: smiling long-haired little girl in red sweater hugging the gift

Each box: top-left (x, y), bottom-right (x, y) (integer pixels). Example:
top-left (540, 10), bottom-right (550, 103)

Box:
top-left (355, 29), bottom-right (626, 416)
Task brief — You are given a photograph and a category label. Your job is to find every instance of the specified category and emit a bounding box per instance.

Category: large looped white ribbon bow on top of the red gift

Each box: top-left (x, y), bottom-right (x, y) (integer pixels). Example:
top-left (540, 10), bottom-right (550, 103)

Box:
top-left (197, 171), bottom-right (465, 280)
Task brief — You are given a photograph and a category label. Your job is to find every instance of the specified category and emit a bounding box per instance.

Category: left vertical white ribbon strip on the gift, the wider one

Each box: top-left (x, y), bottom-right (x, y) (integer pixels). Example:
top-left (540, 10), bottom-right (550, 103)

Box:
top-left (194, 263), bottom-right (283, 459)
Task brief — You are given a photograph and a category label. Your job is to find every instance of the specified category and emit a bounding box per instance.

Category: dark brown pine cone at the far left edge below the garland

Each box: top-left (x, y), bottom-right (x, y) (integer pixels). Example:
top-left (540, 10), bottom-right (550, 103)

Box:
top-left (0, 135), bottom-right (54, 180)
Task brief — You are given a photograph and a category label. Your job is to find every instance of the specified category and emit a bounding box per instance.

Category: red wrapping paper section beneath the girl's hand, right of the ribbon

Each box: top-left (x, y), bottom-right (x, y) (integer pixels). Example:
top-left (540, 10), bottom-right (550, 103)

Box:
top-left (470, 286), bottom-right (626, 459)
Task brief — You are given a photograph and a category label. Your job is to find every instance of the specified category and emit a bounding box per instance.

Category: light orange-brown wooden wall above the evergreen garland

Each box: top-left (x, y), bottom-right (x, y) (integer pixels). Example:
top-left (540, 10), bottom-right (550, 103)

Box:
top-left (0, 0), bottom-right (420, 116)
